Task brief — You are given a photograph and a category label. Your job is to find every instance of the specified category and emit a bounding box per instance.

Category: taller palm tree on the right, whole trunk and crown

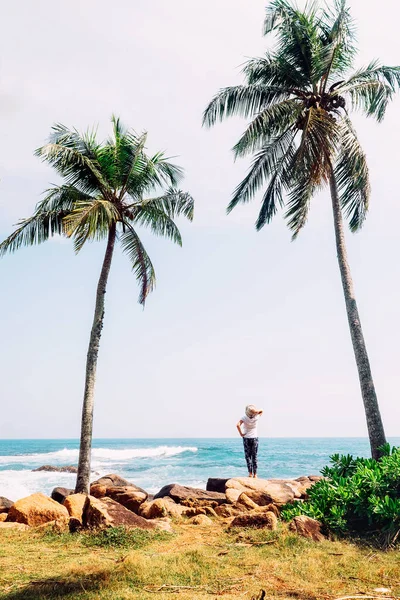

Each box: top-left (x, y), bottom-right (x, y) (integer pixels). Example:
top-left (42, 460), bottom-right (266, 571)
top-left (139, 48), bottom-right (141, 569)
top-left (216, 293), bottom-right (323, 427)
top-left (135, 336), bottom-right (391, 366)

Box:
top-left (203, 0), bottom-right (400, 458)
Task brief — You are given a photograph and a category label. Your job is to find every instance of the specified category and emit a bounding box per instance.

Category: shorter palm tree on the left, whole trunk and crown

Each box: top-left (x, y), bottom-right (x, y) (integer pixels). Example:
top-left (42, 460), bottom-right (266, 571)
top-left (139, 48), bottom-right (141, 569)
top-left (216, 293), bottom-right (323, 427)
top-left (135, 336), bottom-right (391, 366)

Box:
top-left (0, 117), bottom-right (193, 493)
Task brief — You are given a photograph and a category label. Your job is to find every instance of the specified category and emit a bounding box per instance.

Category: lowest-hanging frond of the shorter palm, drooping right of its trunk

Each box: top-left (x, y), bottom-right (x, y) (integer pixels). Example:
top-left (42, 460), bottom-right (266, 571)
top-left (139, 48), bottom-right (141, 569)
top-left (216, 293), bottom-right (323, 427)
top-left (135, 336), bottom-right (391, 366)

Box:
top-left (119, 222), bottom-right (156, 305)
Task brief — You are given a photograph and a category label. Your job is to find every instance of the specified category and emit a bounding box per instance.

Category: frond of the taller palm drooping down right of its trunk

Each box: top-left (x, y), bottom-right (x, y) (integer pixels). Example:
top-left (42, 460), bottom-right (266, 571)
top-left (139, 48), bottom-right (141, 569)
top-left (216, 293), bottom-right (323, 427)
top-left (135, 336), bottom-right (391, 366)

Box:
top-left (334, 118), bottom-right (371, 231)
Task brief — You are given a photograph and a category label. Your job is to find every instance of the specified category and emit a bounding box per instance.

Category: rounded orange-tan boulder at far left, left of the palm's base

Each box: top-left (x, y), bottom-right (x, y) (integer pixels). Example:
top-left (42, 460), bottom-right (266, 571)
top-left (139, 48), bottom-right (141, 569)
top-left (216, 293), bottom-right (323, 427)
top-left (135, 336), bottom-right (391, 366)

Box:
top-left (7, 494), bottom-right (69, 527)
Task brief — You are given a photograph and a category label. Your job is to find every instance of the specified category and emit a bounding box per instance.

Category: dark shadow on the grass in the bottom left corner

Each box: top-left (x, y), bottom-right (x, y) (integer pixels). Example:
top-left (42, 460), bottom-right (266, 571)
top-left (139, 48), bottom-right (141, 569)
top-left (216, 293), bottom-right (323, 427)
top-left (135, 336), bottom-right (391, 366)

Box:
top-left (0, 570), bottom-right (114, 600)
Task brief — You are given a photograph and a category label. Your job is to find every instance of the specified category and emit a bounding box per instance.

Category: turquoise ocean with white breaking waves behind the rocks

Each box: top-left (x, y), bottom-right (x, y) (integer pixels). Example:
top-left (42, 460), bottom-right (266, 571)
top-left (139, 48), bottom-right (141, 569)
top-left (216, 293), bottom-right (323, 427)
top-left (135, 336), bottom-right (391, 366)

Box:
top-left (0, 437), bottom-right (400, 500)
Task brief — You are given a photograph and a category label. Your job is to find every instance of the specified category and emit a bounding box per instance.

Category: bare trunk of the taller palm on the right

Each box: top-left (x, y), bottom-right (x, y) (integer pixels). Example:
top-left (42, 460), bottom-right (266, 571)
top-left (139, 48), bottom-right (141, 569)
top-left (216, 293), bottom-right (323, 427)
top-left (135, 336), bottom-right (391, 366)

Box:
top-left (330, 173), bottom-right (386, 459)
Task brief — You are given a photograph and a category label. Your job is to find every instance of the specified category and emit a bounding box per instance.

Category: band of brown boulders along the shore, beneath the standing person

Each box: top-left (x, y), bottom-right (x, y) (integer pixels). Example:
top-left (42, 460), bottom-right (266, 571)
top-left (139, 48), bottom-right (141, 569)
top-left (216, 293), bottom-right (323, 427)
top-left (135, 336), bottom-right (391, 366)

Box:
top-left (0, 474), bottom-right (324, 541)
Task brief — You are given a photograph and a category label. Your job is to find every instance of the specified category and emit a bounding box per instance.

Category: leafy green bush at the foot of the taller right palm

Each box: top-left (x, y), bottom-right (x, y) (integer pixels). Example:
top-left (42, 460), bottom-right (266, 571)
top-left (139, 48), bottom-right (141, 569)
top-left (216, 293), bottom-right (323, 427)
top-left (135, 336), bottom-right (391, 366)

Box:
top-left (282, 444), bottom-right (400, 546)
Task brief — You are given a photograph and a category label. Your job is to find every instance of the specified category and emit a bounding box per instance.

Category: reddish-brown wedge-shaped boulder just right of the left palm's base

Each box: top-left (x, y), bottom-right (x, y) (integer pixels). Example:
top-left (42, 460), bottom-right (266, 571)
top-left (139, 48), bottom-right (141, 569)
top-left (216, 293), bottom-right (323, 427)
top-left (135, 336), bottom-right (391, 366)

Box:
top-left (83, 496), bottom-right (155, 529)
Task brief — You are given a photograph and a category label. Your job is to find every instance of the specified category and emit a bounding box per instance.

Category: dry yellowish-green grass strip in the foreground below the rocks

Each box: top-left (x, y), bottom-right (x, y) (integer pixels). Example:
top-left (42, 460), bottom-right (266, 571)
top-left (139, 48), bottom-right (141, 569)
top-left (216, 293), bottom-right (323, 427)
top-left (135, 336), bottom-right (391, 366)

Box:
top-left (0, 522), bottom-right (400, 600)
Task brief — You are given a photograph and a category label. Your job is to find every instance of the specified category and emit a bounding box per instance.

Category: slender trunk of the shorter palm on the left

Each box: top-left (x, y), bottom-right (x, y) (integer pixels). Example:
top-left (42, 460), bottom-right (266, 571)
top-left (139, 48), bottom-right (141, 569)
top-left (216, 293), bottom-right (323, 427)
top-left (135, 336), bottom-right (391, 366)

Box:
top-left (75, 223), bottom-right (116, 494)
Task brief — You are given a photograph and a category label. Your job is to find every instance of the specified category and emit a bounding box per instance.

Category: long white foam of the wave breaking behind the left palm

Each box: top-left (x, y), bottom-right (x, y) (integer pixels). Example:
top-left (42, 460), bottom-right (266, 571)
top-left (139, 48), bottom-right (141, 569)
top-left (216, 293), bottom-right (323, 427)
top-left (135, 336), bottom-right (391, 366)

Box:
top-left (0, 446), bottom-right (197, 465)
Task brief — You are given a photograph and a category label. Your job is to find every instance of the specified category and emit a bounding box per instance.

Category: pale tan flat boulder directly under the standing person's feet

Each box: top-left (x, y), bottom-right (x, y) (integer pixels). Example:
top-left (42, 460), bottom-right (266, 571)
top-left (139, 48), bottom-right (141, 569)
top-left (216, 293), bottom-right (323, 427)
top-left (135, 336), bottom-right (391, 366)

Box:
top-left (225, 477), bottom-right (300, 506)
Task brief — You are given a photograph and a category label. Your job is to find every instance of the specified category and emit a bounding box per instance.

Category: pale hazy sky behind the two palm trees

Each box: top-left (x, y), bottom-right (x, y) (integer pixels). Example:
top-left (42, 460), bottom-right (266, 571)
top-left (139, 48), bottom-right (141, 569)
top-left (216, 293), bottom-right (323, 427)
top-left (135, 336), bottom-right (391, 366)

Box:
top-left (0, 0), bottom-right (400, 438)
